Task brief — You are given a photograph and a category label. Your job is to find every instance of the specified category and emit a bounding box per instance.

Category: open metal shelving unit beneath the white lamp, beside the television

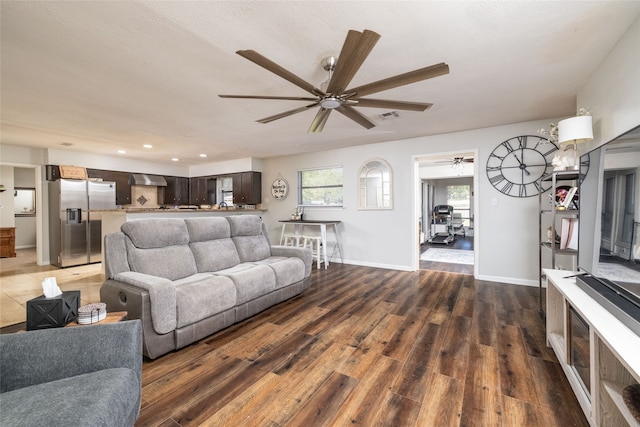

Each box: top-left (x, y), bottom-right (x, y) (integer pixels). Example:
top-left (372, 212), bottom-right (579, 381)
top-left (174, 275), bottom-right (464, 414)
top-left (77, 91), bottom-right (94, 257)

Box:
top-left (538, 171), bottom-right (580, 310)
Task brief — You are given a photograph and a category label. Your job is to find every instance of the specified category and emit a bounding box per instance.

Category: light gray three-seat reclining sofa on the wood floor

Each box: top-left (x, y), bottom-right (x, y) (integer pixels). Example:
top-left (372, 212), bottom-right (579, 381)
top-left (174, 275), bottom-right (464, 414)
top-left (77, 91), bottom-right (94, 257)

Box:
top-left (100, 215), bottom-right (312, 359)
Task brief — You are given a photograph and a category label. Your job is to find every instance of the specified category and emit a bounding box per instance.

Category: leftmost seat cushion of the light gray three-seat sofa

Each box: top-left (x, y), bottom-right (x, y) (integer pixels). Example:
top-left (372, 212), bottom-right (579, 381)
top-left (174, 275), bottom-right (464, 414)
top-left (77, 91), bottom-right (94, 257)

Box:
top-left (175, 275), bottom-right (236, 328)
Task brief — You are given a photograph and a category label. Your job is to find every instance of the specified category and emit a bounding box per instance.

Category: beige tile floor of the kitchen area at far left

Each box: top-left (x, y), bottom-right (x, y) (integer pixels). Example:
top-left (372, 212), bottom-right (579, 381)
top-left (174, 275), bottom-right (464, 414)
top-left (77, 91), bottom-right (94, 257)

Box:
top-left (0, 248), bottom-right (104, 327)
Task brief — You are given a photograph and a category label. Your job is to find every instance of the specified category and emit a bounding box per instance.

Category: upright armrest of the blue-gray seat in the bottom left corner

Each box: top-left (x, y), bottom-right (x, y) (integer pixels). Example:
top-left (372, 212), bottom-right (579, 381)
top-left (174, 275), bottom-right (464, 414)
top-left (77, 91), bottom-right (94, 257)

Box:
top-left (0, 320), bottom-right (142, 393)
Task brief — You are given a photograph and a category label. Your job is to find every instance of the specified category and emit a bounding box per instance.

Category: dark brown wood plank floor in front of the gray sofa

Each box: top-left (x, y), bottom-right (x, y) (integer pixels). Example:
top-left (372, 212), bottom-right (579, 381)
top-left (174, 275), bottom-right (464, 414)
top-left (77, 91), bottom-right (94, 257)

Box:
top-left (136, 264), bottom-right (588, 427)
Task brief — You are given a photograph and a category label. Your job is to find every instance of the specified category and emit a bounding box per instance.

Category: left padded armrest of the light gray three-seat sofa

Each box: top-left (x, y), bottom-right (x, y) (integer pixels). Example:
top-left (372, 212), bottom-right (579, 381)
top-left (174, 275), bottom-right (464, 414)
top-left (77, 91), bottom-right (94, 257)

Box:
top-left (114, 271), bottom-right (178, 334)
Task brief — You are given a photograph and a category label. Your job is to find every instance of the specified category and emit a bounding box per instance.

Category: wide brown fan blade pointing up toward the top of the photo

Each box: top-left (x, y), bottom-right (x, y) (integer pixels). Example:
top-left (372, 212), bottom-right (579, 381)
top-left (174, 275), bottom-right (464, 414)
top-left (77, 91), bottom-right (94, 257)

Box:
top-left (327, 30), bottom-right (380, 95)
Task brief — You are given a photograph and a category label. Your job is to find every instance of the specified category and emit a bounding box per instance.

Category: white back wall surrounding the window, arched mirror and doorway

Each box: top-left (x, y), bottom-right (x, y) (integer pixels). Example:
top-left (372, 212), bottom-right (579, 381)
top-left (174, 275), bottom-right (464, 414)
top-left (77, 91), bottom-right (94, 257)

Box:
top-left (263, 120), bottom-right (560, 284)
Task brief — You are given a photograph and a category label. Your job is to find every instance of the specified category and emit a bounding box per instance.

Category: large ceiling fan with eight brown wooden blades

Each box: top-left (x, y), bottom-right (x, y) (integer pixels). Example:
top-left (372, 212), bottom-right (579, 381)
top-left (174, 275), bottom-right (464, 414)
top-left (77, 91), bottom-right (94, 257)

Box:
top-left (218, 30), bottom-right (449, 133)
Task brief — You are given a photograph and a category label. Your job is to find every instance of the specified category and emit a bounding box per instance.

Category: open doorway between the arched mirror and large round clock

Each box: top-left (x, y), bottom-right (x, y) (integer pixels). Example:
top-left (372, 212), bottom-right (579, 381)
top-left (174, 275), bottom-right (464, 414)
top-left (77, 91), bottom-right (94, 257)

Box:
top-left (416, 152), bottom-right (476, 274)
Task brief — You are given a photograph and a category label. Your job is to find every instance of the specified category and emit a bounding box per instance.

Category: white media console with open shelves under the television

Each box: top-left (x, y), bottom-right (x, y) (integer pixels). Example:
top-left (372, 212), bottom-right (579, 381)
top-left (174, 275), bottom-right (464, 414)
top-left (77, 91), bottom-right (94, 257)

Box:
top-left (545, 269), bottom-right (640, 427)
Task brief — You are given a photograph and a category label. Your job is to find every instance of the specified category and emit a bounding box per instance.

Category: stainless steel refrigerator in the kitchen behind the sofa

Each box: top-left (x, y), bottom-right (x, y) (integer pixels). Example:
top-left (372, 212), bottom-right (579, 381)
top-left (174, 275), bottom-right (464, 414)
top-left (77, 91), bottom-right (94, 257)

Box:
top-left (49, 179), bottom-right (116, 267)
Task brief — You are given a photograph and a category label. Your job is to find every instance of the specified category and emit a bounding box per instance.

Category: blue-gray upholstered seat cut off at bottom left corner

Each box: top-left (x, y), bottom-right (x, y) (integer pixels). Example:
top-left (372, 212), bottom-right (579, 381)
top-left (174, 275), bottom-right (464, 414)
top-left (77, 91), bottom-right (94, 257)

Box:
top-left (0, 320), bottom-right (142, 427)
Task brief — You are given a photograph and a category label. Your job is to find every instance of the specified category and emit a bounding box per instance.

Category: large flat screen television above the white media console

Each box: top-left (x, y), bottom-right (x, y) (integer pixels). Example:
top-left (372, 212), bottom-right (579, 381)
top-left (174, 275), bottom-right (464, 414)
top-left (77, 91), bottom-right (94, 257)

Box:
top-left (576, 126), bottom-right (640, 335)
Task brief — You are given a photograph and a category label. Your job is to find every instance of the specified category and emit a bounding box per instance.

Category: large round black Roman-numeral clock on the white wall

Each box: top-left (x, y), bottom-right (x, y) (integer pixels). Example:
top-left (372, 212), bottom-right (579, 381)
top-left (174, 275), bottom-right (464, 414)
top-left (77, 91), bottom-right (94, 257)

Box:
top-left (487, 135), bottom-right (558, 197)
